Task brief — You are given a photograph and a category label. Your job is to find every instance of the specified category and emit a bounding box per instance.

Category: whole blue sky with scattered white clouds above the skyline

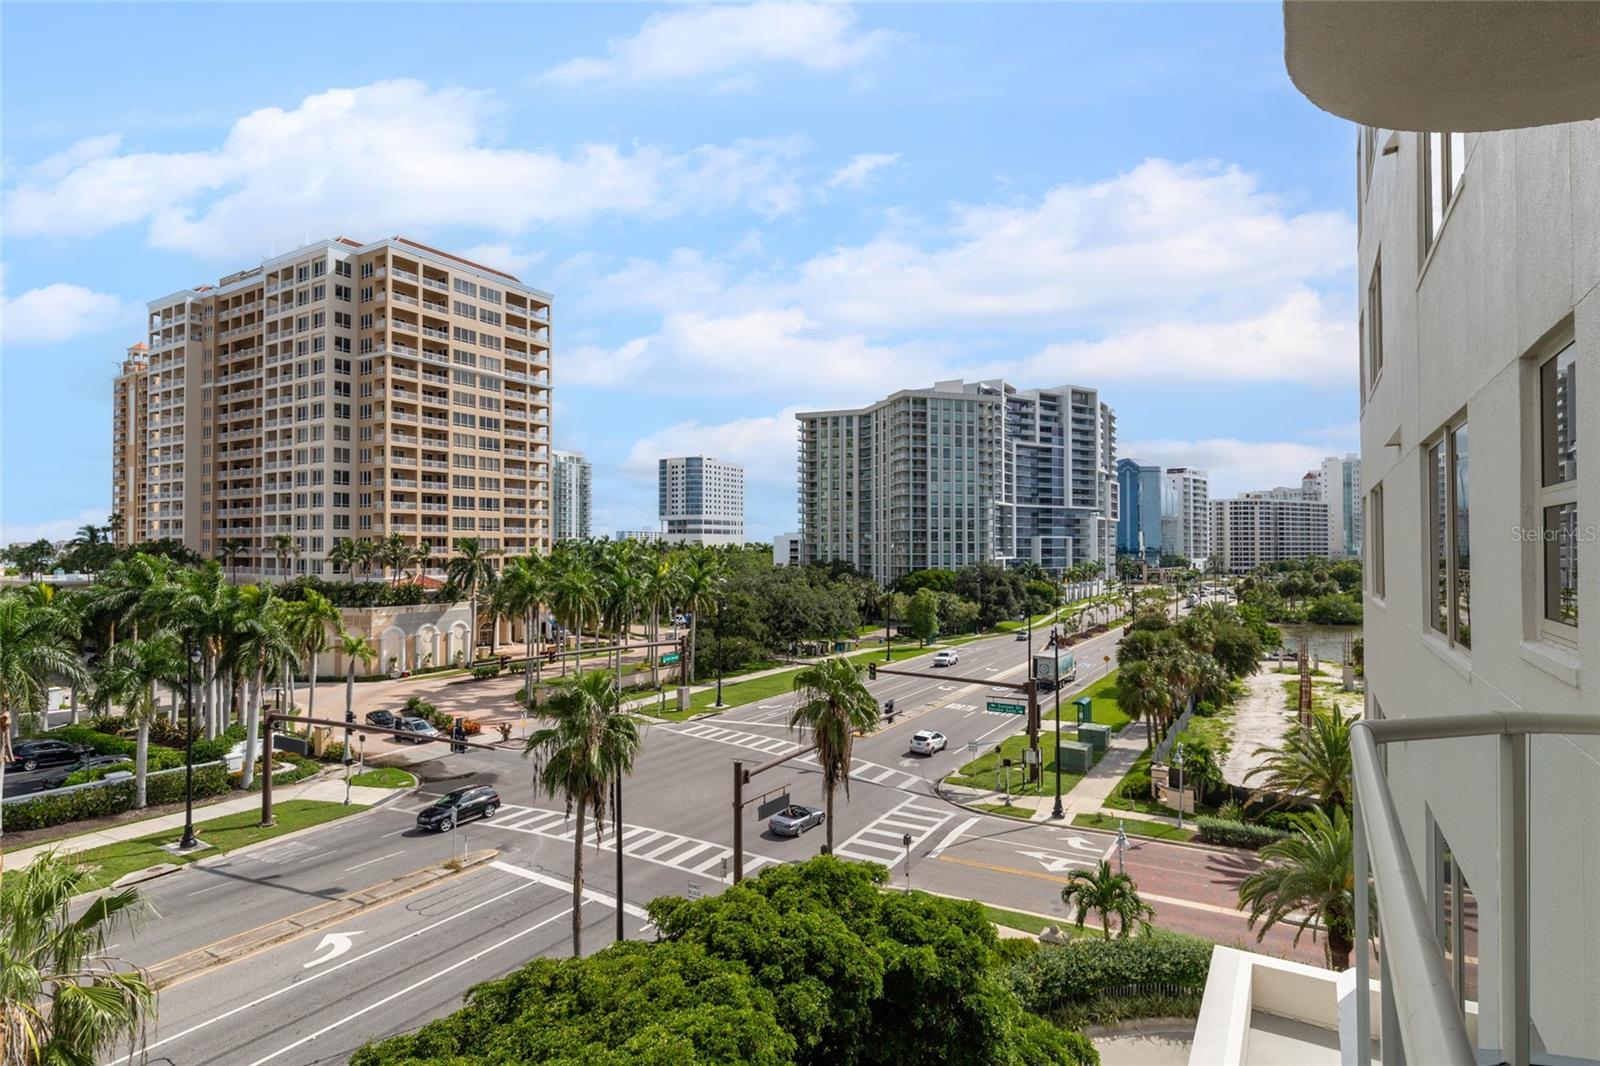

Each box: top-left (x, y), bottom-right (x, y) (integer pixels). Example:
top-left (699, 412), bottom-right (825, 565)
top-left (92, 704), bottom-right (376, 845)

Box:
top-left (0, 3), bottom-right (1357, 541)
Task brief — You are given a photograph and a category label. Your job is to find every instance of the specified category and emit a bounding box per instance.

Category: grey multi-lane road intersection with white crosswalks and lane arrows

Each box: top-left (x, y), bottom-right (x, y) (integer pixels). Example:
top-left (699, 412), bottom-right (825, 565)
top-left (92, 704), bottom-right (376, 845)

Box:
top-left (103, 614), bottom-right (1315, 1066)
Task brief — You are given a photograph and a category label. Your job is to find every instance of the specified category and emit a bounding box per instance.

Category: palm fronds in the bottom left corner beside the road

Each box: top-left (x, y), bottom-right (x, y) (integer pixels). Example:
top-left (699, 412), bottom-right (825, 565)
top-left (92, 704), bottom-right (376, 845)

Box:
top-left (0, 852), bottom-right (155, 1066)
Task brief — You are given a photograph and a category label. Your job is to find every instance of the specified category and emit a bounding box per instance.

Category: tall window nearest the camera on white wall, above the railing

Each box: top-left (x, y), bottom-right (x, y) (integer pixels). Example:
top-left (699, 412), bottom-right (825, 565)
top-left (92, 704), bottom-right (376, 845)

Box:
top-left (1538, 343), bottom-right (1579, 630)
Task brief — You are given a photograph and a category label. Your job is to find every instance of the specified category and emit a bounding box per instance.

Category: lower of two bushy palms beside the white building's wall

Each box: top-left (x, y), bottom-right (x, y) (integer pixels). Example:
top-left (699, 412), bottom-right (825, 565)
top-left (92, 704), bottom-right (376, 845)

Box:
top-left (1238, 807), bottom-right (1378, 972)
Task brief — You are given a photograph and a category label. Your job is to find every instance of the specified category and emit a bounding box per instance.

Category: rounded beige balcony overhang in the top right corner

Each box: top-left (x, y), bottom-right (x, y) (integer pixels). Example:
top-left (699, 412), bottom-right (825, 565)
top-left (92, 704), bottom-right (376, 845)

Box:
top-left (1283, 0), bottom-right (1600, 131)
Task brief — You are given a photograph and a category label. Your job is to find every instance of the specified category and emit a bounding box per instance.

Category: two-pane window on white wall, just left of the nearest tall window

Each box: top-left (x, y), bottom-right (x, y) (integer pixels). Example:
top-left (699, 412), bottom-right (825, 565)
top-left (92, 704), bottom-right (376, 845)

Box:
top-left (1426, 419), bottom-right (1472, 648)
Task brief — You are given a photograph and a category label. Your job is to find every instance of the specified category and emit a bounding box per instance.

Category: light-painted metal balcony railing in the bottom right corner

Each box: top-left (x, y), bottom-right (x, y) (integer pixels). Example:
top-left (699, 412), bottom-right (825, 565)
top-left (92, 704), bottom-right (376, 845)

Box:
top-left (1350, 711), bottom-right (1600, 1066)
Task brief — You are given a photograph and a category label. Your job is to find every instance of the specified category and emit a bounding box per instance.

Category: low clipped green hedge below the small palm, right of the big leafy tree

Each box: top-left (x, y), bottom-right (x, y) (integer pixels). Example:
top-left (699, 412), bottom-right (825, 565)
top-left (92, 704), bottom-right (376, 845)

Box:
top-left (1010, 932), bottom-right (1213, 1013)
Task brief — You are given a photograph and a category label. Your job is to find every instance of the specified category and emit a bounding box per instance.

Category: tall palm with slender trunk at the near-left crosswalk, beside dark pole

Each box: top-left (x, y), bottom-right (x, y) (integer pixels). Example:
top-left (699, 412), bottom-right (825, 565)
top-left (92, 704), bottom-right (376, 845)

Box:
top-left (522, 671), bottom-right (640, 959)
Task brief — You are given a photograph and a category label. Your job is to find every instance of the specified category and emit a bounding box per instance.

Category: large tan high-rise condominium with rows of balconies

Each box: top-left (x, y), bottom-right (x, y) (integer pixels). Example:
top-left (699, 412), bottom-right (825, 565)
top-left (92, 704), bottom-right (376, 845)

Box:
top-left (115, 237), bottom-right (550, 576)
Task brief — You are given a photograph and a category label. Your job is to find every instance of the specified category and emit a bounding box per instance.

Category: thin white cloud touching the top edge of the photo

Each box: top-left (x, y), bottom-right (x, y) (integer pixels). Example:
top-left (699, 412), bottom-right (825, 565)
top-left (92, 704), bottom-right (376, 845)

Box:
top-left (541, 3), bottom-right (896, 88)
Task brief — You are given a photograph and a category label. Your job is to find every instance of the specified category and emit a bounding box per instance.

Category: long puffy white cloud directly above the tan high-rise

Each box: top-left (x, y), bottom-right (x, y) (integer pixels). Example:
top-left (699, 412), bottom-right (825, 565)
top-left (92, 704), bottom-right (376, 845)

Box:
top-left (6, 80), bottom-right (803, 259)
